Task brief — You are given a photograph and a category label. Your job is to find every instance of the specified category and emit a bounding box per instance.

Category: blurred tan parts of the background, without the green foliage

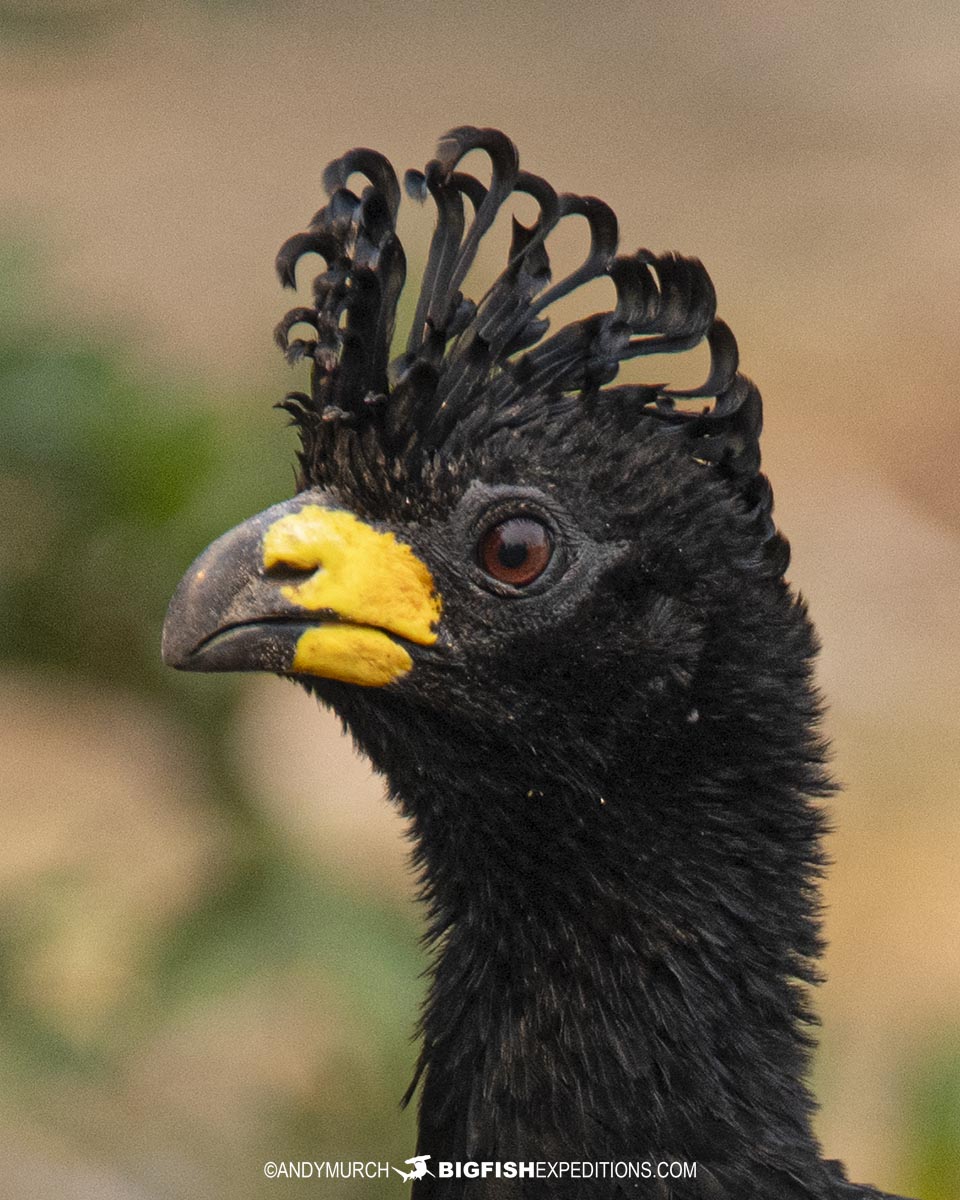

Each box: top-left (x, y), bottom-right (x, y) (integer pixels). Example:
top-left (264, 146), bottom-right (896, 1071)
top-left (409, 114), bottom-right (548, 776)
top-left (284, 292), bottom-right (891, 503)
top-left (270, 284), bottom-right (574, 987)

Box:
top-left (0, 0), bottom-right (960, 1200)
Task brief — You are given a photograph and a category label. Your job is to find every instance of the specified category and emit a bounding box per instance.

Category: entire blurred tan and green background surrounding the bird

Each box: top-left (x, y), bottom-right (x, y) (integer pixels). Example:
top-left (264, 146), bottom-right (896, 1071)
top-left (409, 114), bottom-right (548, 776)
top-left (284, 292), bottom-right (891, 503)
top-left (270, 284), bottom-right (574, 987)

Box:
top-left (0, 0), bottom-right (960, 1200)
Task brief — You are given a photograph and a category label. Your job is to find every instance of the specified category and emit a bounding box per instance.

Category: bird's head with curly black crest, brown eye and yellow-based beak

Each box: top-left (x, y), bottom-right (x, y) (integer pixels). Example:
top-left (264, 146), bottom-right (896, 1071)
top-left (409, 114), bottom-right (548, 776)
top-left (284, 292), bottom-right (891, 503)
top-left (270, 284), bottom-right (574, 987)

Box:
top-left (163, 127), bottom-right (787, 787)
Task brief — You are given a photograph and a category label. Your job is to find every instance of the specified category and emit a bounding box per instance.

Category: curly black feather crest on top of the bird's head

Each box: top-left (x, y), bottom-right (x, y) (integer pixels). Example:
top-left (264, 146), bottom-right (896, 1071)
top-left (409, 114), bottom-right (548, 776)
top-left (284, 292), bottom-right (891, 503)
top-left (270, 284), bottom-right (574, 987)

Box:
top-left (276, 126), bottom-right (786, 569)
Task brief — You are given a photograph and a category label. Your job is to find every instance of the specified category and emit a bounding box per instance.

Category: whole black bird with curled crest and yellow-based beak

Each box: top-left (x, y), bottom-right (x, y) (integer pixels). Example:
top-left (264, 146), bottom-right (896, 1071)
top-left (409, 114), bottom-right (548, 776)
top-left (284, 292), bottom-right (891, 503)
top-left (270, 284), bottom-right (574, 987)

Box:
top-left (163, 127), bottom-right (912, 1200)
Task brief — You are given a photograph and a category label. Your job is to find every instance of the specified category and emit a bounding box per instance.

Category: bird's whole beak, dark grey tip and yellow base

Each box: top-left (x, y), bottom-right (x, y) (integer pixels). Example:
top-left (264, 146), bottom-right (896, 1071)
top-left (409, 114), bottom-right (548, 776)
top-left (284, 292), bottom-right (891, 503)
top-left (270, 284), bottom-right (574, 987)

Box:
top-left (163, 492), bottom-right (440, 688)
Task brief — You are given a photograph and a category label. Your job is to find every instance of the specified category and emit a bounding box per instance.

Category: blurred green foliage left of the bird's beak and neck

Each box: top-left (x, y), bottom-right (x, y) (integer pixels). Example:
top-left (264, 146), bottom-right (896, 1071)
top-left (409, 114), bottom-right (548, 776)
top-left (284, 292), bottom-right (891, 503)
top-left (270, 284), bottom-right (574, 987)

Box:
top-left (0, 247), bottom-right (422, 1200)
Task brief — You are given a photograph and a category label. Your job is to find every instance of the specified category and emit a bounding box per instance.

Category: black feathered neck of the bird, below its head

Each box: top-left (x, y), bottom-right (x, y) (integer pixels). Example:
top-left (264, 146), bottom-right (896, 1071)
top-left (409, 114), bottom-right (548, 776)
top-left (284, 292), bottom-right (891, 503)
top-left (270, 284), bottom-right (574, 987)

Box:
top-left (369, 648), bottom-right (826, 1180)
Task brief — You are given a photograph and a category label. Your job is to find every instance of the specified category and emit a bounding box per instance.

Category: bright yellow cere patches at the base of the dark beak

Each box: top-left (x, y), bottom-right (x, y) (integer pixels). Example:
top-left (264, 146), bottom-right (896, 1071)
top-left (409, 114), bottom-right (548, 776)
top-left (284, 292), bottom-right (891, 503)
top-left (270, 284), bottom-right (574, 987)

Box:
top-left (263, 504), bottom-right (442, 688)
